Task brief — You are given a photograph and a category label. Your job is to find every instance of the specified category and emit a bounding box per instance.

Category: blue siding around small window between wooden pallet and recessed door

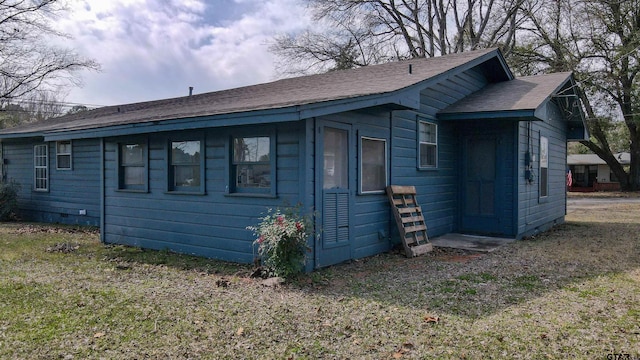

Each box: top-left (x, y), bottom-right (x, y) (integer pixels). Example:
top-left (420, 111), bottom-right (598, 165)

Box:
top-left (391, 69), bottom-right (487, 237)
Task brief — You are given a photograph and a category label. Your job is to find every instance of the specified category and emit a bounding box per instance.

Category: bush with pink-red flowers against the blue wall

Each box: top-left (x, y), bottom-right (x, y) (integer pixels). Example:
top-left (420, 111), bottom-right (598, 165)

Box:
top-left (247, 208), bottom-right (313, 278)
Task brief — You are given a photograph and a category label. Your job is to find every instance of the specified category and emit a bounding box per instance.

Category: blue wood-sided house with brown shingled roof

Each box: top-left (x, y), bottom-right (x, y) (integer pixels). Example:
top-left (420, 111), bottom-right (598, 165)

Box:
top-left (0, 49), bottom-right (586, 268)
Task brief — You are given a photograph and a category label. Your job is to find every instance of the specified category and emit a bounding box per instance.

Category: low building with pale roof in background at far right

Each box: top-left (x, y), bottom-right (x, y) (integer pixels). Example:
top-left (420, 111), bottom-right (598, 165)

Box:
top-left (567, 152), bottom-right (631, 191)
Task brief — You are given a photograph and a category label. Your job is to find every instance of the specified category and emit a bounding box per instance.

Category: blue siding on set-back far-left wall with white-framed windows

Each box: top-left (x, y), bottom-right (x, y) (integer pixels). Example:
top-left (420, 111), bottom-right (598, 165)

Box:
top-left (2, 139), bottom-right (100, 226)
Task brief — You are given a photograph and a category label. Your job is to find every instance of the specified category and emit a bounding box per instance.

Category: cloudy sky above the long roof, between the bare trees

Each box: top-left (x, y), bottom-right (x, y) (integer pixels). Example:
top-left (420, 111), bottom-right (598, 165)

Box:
top-left (56, 0), bottom-right (308, 105)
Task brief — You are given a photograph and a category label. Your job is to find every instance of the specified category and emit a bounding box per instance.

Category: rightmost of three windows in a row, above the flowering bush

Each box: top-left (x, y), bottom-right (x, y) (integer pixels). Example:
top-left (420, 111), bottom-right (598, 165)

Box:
top-left (232, 136), bottom-right (273, 193)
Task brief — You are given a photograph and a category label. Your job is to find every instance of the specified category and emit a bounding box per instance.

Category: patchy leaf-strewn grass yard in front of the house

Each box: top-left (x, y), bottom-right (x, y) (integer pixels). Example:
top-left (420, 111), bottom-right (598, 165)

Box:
top-left (0, 204), bottom-right (640, 359)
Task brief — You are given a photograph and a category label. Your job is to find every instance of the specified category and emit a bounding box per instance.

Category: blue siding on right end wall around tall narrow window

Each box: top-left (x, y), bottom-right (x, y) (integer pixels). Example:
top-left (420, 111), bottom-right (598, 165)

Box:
top-left (517, 102), bottom-right (567, 238)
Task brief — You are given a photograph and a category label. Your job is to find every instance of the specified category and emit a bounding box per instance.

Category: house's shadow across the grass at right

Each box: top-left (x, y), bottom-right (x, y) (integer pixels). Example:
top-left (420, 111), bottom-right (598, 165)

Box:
top-left (293, 222), bottom-right (640, 318)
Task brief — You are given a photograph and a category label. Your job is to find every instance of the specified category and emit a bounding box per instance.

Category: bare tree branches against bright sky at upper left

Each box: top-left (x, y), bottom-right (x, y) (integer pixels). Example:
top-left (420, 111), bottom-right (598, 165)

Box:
top-left (0, 0), bottom-right (99, 104)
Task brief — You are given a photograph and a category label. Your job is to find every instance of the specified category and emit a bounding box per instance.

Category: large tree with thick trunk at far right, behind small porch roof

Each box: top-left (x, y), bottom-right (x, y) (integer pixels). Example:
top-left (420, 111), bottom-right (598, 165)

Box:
top-left (509, 0), bottom-right (640, 190)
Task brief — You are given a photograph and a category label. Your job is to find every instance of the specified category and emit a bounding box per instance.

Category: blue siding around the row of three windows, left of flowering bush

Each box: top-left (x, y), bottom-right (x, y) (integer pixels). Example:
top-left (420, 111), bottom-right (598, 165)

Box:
top-left (104, 122), bottom-right (305, 263)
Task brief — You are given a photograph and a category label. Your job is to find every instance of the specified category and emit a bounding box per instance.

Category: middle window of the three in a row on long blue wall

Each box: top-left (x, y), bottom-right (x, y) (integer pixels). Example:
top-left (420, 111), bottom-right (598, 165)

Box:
top-left (169, 140), bottom-right (204, 192)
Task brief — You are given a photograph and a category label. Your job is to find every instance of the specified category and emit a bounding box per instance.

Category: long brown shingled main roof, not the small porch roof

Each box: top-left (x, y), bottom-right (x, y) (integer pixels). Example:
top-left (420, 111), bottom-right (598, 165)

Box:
top-left (0, 49), bottom-right (504, 138)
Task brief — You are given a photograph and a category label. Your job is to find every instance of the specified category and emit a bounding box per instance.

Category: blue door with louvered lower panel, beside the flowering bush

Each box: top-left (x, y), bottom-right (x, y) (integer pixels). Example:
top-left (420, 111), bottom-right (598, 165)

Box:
top-left (316, 122), bottom-right (353, 267)
